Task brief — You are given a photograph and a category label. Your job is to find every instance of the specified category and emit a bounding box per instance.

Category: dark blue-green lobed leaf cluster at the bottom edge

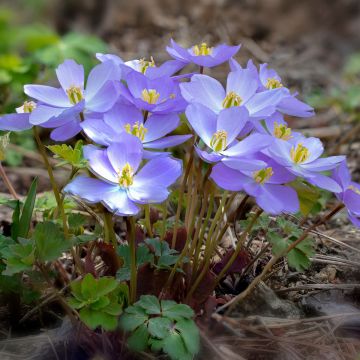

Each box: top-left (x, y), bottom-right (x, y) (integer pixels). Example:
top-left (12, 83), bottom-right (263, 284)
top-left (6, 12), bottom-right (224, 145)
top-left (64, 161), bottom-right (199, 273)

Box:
top-left (120, 295), bottom-right (200, 360)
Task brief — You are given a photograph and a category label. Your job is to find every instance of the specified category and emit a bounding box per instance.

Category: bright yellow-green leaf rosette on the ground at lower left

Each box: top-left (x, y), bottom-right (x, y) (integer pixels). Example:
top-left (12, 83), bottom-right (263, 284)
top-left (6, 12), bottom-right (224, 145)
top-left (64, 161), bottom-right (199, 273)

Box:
top-left (68, 274), bottom-right (128, 331)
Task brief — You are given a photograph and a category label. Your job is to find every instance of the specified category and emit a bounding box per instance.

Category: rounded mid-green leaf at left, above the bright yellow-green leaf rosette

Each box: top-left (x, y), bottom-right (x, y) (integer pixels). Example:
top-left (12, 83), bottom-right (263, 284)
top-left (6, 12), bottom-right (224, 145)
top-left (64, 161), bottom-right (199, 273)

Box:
top-left (32, 222), bottom-right (71, 262)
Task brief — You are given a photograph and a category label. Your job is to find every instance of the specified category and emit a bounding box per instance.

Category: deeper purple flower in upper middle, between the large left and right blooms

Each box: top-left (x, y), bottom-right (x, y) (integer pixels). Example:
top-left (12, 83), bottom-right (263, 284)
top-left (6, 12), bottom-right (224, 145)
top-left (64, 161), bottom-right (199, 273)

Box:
top-left (120, 71), bottom-right (186, 114)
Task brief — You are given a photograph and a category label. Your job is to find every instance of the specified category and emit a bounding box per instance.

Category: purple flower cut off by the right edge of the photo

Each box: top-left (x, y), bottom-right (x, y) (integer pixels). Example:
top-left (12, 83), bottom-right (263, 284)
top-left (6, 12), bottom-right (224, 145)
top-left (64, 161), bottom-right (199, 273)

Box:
top-left (332, 161), bottom-right (360, 227)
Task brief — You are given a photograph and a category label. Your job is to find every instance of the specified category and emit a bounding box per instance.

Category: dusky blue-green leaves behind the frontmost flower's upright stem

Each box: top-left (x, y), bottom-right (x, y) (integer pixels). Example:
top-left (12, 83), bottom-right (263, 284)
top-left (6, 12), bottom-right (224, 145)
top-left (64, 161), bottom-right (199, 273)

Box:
top-left (116, 239), bottom-right (188, 281)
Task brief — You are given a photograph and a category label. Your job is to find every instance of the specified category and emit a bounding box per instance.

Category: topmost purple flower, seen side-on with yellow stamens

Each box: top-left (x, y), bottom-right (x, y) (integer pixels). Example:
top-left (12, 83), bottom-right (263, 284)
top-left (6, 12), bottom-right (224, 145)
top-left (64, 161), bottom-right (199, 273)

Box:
top-left (166, 39), bottom-right (240, 67)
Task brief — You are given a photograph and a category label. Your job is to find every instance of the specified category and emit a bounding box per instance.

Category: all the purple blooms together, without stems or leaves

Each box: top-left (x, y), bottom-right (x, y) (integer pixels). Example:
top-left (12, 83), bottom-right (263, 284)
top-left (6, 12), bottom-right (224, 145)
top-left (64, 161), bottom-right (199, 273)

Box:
top-left (0, 41), bottom-right (360, 226)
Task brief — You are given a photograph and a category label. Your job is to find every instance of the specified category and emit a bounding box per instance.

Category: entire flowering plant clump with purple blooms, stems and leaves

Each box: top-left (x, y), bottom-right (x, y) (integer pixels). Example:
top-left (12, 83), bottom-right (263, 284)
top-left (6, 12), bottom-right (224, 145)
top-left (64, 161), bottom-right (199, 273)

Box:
top-left (0, 41), bottom-right (360, 359)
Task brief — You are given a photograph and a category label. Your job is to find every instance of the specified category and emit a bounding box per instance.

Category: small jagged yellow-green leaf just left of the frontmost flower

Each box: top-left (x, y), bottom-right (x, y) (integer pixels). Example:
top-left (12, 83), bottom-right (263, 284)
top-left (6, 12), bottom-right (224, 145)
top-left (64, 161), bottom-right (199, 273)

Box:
top-left (48, 140), bottom-right (87, 169)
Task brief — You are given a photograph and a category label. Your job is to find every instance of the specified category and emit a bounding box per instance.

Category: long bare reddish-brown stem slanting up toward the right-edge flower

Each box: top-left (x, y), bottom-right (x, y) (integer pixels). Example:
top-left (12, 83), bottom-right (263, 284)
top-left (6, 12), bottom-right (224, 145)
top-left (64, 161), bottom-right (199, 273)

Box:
top-left (217, 203), bottom-right (344, 313)
